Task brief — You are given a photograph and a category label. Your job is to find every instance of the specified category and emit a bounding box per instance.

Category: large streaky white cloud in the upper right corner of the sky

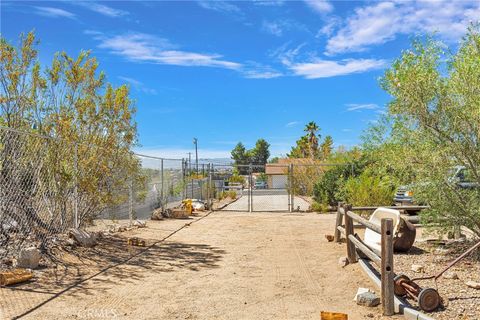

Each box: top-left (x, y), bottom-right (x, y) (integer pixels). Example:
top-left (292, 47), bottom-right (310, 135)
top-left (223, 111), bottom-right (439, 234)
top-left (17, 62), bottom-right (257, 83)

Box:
top-left (326, 1), bottom-right (480, 55)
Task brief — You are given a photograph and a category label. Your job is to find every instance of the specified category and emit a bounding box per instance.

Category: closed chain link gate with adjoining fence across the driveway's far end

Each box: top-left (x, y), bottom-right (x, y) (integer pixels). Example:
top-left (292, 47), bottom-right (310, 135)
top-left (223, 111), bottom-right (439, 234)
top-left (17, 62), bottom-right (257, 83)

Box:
top-left (213, 159), bottom-right (351, 212)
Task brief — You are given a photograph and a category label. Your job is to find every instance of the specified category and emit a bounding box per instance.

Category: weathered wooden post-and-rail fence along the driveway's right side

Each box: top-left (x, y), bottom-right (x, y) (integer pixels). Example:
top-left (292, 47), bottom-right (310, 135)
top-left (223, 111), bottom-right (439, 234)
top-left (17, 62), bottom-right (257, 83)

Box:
top-left (334, 203), bottom-right (395, 316)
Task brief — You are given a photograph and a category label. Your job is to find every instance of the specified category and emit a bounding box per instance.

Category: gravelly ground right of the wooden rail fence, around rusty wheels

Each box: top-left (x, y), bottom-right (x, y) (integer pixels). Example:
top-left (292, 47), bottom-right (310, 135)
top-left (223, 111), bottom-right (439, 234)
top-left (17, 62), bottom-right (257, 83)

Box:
top-left (395, 240), bottom-right (480, 320)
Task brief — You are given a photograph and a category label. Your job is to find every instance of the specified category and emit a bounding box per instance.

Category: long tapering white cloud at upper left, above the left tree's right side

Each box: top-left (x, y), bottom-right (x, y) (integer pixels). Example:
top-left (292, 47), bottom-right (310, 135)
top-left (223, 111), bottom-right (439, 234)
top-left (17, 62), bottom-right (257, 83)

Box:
top-left (86, 31), bottom-right (242, 69)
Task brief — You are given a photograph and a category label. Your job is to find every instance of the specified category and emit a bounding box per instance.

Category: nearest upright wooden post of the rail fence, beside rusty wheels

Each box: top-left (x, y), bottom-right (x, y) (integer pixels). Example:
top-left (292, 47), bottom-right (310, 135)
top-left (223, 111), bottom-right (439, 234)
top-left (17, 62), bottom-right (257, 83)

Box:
top-left (381, 218), bottom-right (395, 316)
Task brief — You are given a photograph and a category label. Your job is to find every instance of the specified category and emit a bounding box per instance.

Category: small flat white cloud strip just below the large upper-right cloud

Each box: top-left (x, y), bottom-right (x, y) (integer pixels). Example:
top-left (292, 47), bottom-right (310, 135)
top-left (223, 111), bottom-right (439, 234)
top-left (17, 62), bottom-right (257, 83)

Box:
top-left (289, 59), bottom-right (386, 79)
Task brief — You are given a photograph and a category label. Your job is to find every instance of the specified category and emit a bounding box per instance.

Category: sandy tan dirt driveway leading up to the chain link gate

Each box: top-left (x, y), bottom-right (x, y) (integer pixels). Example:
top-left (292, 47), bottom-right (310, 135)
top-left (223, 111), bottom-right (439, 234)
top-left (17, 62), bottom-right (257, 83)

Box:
top-left (0, 212), bottom-right (386, 320)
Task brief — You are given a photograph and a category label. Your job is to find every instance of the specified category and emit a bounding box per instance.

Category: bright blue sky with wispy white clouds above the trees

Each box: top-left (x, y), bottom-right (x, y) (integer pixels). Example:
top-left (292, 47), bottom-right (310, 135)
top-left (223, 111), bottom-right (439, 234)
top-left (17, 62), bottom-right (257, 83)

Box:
top-left (0, 0), bottom-right (480, 158)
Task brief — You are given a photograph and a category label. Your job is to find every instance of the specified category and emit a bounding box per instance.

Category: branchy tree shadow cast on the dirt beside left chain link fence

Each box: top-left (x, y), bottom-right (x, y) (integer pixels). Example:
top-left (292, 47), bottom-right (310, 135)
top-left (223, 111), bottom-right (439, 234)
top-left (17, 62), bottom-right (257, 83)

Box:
top-left (0, 232), bottom-right (226, 319)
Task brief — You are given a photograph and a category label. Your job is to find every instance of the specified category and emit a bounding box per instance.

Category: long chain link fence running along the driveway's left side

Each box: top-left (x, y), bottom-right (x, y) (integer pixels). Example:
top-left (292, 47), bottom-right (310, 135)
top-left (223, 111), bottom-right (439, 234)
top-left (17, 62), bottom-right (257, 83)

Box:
top-left (0, 127), bottom-right (213, 259)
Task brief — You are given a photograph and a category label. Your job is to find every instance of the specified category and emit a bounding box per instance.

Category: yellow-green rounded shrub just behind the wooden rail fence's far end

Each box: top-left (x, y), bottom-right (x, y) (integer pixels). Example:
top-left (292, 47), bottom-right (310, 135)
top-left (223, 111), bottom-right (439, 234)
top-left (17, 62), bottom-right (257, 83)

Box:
top-left (343, 170), bottom-right (396, 206)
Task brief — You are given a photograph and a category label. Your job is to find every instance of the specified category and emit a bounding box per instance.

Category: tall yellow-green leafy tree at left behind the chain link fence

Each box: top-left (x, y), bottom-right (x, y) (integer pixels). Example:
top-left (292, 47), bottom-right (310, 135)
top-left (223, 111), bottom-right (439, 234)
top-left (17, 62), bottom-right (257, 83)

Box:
top-left (0, 32), bottom-right (143, 232)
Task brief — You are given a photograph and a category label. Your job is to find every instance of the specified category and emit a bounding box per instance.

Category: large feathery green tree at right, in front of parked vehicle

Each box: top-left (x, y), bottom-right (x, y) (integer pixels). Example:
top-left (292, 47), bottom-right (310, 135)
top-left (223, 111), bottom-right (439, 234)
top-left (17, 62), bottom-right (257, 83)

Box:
top-left (381, 25), bottom-right (480, 235)
